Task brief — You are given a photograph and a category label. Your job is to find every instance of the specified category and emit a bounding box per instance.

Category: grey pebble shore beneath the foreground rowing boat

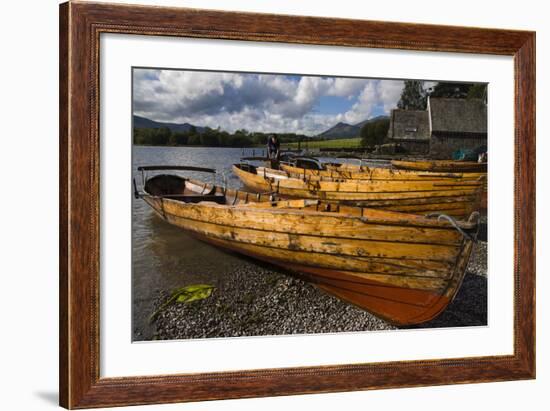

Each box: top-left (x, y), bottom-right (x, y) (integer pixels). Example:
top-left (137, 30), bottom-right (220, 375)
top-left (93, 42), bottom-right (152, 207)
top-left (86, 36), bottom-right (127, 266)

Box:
top-left (153, 242), bottom-right (487, 340)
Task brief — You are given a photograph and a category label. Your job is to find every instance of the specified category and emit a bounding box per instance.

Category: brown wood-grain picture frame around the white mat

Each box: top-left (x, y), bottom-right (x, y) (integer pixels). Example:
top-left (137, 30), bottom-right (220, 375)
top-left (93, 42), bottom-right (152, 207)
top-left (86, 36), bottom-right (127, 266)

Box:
top-left (59, 2), bottom-right (535, 408)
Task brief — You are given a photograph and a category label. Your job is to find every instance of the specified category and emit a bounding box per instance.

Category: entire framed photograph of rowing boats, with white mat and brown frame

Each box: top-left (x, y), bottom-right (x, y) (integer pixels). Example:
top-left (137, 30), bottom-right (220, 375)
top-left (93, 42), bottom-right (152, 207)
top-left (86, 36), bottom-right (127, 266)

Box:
top-left (60, 2), bottom-right (535, 408)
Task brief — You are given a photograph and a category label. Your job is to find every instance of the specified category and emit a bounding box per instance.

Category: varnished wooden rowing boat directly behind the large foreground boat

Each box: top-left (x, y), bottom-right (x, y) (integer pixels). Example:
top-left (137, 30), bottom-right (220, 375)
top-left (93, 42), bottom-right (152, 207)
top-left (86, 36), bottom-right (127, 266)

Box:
top-left (233, 164), bottom-right (483, 218)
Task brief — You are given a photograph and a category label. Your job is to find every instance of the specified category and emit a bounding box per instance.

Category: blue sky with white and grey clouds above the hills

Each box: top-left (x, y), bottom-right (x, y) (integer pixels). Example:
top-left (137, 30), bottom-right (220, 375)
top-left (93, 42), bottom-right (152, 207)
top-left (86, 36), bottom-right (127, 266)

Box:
top-left (133, 69), bottom-right (426, 135)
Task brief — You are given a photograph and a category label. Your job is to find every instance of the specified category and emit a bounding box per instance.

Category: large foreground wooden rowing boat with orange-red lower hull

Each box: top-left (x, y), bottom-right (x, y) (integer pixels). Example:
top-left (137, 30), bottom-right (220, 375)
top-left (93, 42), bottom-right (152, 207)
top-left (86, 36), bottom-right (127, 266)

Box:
top-left (134, 166), bottom-right (484, 325)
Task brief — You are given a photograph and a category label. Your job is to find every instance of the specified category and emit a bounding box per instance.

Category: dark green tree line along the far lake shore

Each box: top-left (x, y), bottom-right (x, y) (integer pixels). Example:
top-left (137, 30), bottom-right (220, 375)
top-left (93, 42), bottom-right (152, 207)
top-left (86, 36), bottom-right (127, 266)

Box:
top-left (134, 126), bottom-right (314, 147)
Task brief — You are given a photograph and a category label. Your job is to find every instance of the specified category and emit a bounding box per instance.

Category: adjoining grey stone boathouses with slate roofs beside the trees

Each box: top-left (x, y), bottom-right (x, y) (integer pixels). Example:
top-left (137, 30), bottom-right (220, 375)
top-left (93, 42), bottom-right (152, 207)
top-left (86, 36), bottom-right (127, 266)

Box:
top-left (388, 97), bottom-right (487, 159)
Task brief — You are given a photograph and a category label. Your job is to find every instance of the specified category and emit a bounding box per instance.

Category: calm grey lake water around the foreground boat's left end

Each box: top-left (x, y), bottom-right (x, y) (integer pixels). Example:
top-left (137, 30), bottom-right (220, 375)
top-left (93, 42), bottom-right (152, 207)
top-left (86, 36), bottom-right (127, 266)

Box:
top-left (132, 146), bottom-right (390, 340)
